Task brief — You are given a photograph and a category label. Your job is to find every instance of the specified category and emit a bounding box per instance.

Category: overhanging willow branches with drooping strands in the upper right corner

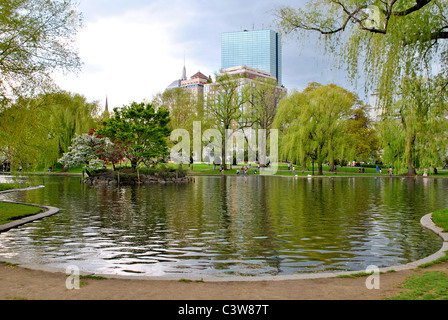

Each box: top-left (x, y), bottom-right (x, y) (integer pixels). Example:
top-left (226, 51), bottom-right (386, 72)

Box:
top-left (277, 0), bottom-right (448, 101)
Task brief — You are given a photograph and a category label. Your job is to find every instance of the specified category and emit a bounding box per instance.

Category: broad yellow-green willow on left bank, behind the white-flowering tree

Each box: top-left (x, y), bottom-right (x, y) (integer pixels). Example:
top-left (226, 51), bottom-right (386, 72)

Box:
top-left (0, 92), bottom-right (99, 169)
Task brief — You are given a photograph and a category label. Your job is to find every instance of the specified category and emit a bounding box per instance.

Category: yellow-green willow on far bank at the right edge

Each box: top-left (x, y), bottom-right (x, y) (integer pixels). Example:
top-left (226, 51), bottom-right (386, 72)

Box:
top-left (379, 78), bottom-right (448, 175)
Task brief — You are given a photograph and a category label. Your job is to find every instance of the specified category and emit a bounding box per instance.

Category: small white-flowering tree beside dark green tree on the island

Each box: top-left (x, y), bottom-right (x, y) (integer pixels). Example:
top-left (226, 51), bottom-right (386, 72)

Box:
top-left (59, 133), bottom-right (113, 177)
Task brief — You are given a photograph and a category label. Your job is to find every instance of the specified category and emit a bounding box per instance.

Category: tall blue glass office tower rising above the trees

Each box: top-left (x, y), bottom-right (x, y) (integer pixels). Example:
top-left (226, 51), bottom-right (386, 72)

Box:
top-left (221, 30), bottom-right (282, 85)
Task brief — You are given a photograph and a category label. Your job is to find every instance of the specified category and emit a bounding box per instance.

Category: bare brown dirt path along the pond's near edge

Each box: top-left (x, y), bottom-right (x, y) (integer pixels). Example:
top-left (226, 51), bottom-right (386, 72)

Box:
top-left (0, 263), bottom-right (448, 300)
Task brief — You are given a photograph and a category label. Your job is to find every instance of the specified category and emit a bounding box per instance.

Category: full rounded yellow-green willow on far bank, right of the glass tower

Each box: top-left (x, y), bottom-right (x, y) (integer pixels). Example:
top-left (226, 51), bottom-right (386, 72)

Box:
top-left (273, 83), bottom-right (357, 175)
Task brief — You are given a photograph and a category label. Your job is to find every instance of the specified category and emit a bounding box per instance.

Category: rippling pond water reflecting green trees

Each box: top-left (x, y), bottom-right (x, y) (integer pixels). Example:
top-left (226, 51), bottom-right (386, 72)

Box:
top-left (0, 176), bottom-right (448, 276)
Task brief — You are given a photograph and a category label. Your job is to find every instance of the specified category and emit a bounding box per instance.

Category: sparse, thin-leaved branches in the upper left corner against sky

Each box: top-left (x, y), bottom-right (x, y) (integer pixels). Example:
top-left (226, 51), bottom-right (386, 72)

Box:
top-left (0, 0), bottom-right (81, 108)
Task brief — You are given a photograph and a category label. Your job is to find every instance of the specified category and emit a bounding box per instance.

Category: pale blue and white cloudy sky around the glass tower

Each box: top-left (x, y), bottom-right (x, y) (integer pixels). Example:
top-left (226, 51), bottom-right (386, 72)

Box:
top-left (54, 0), bottom-right (365, 109)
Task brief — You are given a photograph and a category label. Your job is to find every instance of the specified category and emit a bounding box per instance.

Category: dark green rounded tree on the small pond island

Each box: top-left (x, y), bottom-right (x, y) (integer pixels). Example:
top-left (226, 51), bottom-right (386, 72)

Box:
top-left (97, 102), bottom-right (171, 170)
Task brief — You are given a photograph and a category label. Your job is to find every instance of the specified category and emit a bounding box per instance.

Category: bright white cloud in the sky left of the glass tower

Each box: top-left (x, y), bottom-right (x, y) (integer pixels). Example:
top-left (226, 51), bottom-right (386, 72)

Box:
top-left (55, 5), bottom-right (198, 107)
